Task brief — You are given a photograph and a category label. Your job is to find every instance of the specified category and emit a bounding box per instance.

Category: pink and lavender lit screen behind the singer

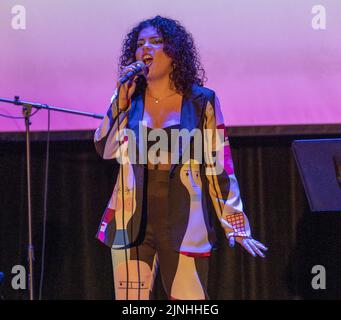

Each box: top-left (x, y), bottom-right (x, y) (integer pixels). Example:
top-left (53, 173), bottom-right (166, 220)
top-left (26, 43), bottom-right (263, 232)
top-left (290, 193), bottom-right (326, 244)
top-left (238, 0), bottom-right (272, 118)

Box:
top-left (0, 0), bottom-right (341, 132)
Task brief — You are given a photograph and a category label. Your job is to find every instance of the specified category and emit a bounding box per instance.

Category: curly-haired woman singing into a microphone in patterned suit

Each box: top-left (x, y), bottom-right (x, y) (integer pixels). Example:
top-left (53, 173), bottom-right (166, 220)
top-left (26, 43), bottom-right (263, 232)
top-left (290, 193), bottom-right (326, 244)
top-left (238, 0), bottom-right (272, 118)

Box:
top-left (95, 16), bottom-right (267, 299)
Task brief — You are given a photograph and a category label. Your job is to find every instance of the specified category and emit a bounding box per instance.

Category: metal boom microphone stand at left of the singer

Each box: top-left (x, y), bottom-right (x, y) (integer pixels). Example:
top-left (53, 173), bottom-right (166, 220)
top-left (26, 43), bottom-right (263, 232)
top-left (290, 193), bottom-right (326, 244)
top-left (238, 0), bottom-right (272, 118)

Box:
top-left (0, 96), bottom-right (104, 300)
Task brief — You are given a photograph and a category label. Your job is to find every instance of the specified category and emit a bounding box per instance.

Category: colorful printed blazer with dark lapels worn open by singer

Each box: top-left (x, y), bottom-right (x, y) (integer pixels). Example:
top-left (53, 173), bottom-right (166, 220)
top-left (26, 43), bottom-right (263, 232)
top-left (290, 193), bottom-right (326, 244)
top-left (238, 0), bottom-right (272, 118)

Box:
top-left (94, 85), bottom-right (250, 256)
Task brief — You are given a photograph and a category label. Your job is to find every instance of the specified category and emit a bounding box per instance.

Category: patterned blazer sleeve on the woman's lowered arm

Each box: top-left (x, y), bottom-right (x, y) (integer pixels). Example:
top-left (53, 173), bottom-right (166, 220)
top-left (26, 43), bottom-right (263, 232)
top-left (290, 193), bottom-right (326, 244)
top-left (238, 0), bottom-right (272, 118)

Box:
top-left (204, 95), bottom-right (251, 237)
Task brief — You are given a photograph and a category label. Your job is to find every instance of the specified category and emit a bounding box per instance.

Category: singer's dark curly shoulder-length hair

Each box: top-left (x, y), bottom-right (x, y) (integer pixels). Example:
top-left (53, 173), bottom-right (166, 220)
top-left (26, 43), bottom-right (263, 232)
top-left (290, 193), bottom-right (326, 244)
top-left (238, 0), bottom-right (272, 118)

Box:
top-left (119, 15), bottom-right (207, 95)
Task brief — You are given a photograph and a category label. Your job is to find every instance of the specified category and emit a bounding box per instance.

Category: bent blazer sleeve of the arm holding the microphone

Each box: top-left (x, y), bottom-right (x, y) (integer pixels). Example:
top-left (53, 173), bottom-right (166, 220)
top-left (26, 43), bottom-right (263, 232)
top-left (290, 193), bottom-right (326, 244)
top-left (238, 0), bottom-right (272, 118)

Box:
top-left (94, 90), bottom-right (131, 159)
